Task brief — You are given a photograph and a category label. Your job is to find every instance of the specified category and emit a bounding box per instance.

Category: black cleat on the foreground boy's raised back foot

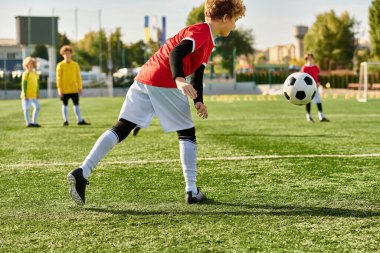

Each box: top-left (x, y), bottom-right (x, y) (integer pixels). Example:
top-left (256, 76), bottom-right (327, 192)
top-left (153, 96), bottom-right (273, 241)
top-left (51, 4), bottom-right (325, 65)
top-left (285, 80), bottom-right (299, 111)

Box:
top-left (67, 168), bottom-right (88, 206)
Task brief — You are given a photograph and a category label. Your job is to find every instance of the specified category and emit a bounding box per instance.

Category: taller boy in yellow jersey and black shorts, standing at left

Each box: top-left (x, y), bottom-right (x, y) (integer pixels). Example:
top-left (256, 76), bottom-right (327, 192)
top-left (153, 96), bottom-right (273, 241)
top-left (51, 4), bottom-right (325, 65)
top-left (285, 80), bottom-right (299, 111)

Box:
top-left (57, 45), bottom-right (90, 126)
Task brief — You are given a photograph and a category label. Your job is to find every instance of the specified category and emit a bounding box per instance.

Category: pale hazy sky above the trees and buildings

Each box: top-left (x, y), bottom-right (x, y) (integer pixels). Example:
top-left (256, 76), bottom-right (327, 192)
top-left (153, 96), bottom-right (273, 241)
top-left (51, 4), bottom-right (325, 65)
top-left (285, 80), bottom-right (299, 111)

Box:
top-left (0, 0), bottom-right (371, 50)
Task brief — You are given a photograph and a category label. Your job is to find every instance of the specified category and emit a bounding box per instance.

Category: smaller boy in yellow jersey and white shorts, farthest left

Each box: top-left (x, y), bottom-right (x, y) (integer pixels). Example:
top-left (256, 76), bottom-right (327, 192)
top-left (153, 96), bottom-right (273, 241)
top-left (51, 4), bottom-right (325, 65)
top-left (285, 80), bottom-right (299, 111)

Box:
top-left (20, 57), bottom-right (41, 127)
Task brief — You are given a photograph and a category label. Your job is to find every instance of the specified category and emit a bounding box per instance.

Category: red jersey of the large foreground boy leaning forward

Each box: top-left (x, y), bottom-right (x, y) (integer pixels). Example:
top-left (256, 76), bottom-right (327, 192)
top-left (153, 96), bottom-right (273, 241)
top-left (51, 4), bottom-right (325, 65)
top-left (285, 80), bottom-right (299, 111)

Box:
top-left (135, 23), bottom-right (215, 88)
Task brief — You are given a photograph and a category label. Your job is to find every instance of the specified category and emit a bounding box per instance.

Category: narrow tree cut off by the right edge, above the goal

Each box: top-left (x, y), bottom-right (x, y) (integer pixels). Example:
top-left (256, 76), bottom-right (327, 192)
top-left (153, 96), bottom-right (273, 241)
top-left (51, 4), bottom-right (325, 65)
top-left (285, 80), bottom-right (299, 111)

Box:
top-left (368, 0), bottom-right (380, 60)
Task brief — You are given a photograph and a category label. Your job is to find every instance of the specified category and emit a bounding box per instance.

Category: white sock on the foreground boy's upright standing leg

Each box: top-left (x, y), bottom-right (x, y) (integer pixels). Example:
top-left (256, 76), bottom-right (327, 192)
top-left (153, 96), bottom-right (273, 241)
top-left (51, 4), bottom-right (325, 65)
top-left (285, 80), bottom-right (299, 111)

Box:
top-left (179, 140), bottom-right (198, 194)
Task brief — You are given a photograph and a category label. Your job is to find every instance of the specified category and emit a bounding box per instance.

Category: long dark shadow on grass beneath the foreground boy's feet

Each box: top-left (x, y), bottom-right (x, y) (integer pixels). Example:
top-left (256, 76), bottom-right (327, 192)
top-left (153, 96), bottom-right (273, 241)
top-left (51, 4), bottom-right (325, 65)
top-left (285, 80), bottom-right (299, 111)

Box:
top-left (85, 199), bottom-right (380, 218)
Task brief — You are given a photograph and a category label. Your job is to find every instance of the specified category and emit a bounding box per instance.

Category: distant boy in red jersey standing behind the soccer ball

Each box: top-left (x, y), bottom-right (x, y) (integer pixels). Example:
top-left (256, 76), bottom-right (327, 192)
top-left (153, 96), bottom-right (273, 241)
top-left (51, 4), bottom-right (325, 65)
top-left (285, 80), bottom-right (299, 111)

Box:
top-left (301, 53), bottom-right (330, 122)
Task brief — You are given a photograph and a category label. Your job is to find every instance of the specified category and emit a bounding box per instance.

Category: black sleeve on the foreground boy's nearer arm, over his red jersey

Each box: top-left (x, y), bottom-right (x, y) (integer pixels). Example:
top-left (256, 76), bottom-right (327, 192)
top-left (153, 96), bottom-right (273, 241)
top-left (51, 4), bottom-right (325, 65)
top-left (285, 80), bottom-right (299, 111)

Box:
top-left (169, 40), bottom-right (193, 80)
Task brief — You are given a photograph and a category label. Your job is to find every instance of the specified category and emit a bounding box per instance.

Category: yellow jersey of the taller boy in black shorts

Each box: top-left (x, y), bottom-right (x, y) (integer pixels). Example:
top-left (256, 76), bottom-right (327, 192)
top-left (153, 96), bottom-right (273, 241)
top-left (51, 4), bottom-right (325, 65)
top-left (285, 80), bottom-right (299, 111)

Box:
top-left (56, 60), bottom-right (82, 94)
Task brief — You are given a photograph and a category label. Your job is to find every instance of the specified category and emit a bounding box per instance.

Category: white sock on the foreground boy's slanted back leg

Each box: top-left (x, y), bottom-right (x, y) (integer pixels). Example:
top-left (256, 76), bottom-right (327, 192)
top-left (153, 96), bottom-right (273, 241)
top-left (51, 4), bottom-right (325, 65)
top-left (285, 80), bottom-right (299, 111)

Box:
top-left (80, 130), bottom-right (119, 179)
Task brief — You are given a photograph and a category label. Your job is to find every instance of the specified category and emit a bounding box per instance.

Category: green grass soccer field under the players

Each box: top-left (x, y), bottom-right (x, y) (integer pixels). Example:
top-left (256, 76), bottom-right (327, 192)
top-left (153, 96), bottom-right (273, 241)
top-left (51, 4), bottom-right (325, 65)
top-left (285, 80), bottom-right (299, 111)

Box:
top-left (0, 96), bottom-right (380, 252)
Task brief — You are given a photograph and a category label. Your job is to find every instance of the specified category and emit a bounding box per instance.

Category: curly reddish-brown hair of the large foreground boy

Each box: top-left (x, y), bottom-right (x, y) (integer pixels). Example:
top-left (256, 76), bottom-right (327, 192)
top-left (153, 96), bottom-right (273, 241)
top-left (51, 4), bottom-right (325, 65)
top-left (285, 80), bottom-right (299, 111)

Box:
top-left (205, 0), bottom-right (245, 20)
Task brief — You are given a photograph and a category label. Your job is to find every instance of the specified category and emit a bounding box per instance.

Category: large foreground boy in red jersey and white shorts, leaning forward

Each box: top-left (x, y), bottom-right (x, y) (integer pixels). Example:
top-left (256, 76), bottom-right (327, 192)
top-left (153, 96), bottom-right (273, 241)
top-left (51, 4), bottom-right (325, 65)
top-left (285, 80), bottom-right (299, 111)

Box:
top-left (67, 0), bottom-right (245, 205)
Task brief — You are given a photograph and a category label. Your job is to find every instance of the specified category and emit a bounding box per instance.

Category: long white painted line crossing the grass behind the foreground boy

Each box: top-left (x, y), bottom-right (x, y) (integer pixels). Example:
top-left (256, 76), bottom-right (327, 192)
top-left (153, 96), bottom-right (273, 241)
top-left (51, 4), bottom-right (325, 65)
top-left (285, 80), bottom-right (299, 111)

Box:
top-left (0, 154), bottom-right (380, 168)
